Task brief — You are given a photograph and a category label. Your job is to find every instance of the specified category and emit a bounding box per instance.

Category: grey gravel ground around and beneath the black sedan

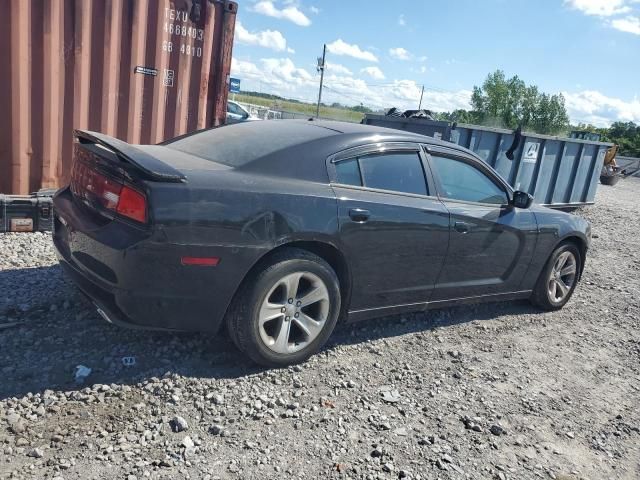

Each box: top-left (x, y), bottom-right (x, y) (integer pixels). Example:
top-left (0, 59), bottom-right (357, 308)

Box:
top-left (0, 179), bottom-right (640, 480)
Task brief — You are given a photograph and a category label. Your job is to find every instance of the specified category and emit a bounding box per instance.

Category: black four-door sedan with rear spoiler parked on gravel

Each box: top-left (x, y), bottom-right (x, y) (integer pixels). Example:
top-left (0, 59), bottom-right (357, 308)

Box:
top-left (54, 120), bottom-right (590, 366)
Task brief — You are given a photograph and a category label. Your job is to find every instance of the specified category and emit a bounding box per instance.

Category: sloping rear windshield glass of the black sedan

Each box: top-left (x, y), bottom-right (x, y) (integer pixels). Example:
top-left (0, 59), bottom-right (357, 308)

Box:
top-left (164, 120), bottom-right (338, 167)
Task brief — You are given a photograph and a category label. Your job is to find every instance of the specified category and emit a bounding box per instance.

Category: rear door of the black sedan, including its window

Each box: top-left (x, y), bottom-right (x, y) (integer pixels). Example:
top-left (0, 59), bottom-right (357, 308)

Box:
top-left (328, 143), bottom-right (449, 316)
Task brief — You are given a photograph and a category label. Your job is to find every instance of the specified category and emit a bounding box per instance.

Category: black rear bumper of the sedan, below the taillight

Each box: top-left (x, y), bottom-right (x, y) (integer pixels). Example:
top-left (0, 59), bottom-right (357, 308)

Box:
top-left (53, 190), bottom-right (255, 332)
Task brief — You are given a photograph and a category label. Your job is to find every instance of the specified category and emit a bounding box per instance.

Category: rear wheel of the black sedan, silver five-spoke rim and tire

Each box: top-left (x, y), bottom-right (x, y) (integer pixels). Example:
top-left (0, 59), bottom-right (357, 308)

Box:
top-left (226, 248), bottom-right (341, 367)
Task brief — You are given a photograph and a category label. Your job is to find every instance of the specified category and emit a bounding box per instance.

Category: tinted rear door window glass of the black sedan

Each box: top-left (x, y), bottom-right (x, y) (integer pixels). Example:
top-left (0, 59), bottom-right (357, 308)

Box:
top-left (336, 152), bottom-right (428, 195)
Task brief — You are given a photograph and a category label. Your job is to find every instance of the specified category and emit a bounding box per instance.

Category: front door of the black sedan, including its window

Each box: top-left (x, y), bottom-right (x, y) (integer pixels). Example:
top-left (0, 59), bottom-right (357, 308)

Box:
top-left (428, 147), bottom-right (537, 301)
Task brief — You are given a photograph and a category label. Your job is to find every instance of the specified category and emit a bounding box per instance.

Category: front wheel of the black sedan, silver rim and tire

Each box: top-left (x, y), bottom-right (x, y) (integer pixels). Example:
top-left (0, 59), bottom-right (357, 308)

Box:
top-left (531, 243), bottom-right (582, 311)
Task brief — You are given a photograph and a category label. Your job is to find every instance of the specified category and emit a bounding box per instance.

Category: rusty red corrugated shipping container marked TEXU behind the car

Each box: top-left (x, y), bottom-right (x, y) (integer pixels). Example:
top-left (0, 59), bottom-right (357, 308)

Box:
top-left (0, 0), bottom-right (237, 194)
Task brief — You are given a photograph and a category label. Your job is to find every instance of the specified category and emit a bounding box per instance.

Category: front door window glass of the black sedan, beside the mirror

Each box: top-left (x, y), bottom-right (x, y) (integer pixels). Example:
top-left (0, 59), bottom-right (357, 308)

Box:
top-left (431, 155), bottom-right (509, 205)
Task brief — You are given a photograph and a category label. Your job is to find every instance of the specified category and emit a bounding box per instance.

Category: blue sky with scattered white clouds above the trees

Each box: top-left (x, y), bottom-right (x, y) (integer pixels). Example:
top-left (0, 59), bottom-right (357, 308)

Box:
top-left (232, 0), bottom-right (640, 125)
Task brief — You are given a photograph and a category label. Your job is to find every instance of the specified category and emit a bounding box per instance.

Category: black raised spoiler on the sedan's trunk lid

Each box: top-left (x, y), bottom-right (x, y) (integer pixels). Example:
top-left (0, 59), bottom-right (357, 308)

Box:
top-left (74, 130), bottom-right (187, 183)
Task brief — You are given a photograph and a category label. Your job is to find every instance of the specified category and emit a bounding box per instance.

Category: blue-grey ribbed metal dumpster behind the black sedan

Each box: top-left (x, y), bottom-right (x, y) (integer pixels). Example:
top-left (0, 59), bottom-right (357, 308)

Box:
top-left (363, 114), bottom-right (612, 208)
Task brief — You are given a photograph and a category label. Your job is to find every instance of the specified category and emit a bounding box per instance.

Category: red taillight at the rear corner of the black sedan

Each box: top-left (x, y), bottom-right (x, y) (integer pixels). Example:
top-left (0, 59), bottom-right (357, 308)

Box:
top-left (71, 162), bottom-right (147, 223)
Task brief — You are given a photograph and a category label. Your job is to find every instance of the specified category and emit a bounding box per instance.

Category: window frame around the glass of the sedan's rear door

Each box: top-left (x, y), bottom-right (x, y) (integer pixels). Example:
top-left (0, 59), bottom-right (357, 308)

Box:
top-left (327, 142), bottom-right (438, 200)
